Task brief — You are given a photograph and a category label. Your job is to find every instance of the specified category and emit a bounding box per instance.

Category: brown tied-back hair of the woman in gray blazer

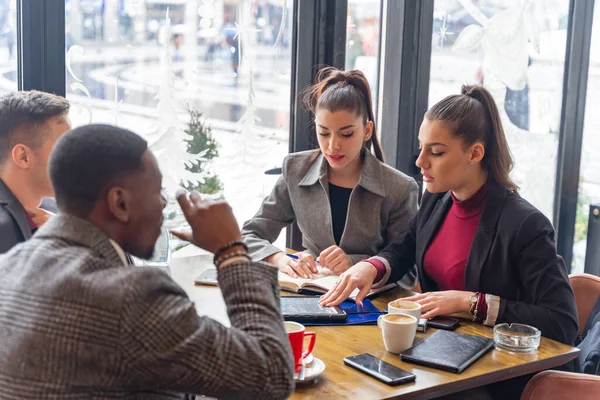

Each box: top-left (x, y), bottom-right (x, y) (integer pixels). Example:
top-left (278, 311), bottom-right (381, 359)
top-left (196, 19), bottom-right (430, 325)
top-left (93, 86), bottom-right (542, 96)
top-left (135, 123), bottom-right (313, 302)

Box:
top-left (303, 67), bottom-right (384, 162)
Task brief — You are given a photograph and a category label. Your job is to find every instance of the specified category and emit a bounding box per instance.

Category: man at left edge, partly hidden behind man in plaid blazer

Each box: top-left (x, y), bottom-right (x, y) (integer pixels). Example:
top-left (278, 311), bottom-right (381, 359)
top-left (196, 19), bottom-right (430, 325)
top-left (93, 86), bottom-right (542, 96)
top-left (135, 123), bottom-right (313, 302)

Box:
top-left (0, 91), bottom-right (71, 253)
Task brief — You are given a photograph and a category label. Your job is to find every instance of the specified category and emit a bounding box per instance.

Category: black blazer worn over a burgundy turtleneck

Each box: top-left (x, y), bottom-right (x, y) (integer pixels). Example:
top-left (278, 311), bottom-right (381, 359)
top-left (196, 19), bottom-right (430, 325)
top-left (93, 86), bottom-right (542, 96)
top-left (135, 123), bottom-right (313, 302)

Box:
top-left (378, 183), bottom-right (577, 345)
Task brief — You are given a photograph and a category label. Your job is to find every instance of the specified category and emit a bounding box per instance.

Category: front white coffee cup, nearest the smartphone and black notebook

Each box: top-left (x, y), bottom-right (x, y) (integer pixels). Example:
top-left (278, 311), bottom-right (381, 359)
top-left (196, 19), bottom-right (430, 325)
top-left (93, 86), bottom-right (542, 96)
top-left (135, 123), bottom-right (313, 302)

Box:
top-left (377, 314), bottom-right (418, 354)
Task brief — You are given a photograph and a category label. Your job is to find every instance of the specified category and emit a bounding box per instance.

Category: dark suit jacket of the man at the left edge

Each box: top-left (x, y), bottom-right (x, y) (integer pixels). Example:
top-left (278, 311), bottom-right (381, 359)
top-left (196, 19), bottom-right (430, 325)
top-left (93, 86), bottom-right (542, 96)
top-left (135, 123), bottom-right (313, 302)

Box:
top-left (0, 179), bottom-right (31, 253)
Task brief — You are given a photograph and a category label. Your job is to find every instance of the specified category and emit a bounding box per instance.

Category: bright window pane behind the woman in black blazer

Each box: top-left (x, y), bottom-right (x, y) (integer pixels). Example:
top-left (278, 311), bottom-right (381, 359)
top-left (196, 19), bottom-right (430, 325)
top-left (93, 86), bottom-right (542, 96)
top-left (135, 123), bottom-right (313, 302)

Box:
top-left (429, 0), bottom-right (569, 219)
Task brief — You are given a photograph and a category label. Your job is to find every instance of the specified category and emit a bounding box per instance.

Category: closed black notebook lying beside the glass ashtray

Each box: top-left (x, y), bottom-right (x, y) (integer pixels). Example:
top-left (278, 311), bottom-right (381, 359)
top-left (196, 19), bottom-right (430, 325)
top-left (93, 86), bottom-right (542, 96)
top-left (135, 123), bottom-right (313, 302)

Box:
top-left (400, 330), bottom-right (494, 374)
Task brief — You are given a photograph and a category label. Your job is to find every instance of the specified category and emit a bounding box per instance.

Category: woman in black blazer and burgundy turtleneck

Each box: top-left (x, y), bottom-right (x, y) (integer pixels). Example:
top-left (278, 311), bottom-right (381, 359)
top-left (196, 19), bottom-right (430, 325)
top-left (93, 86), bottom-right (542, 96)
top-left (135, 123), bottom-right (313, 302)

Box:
top-left (321, 86), bottom-right (577, 345)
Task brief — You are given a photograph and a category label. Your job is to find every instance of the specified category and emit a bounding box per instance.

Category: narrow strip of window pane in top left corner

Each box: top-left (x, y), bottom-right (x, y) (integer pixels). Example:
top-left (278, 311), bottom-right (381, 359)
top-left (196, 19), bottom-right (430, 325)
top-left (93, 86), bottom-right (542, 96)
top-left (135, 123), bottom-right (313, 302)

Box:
top-left (0, 0), bottom-right (18, 94)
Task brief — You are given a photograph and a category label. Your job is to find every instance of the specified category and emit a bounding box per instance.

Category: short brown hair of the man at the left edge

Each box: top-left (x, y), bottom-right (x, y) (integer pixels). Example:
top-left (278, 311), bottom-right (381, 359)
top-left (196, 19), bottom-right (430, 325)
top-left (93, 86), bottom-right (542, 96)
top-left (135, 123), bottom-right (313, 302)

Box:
top-left (0, 90), bottom-right (69, 165)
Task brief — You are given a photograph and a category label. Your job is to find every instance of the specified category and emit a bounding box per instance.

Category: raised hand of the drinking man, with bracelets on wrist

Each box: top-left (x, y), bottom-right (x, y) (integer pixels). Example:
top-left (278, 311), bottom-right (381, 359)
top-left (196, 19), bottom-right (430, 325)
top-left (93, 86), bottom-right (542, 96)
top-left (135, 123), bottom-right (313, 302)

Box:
top-left (171, 189), bottom-right (248, 266)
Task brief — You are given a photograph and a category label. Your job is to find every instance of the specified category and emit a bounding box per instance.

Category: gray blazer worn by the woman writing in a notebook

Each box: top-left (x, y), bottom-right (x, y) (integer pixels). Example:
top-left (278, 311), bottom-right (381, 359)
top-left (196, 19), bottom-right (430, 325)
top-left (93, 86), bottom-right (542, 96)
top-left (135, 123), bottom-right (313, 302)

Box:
top-left (242, 150), bottom-right (418, 287)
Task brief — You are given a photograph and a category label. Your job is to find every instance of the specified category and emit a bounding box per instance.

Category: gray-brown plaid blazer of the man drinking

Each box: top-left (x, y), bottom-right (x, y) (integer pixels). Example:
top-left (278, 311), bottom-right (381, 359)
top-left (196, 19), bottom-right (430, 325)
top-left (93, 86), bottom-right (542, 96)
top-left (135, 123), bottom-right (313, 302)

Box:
top-left (0, 214), bottom-right (294, 399)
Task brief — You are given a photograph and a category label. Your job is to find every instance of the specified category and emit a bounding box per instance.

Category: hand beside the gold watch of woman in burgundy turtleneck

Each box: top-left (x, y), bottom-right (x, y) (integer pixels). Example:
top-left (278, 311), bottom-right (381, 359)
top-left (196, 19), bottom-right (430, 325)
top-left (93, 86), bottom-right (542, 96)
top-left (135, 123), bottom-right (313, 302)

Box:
top-left (403, 290), bottom-right (475, 319)
